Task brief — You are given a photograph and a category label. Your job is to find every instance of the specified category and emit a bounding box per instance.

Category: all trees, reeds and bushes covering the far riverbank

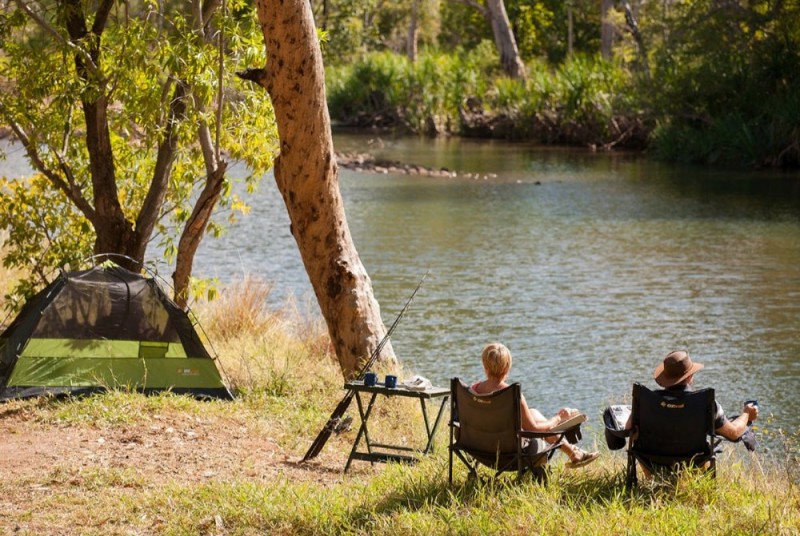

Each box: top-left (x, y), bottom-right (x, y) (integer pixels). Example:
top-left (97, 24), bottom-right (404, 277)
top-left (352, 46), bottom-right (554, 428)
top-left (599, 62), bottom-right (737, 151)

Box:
top-left (315, 0), bottom-right (800, 168)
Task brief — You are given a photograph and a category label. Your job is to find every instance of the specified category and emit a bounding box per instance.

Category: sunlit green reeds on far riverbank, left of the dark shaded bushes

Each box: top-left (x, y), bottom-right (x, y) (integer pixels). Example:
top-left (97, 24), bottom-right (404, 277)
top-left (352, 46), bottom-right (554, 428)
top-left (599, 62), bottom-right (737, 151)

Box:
top-left (327, 48), bottom-right (649, 148)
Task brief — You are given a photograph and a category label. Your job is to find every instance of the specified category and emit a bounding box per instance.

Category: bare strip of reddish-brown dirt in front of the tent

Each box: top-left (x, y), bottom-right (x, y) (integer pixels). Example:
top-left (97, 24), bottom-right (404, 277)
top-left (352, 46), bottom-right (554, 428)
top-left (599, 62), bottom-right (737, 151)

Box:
top-left (0, 406), bottom-right (354, 490)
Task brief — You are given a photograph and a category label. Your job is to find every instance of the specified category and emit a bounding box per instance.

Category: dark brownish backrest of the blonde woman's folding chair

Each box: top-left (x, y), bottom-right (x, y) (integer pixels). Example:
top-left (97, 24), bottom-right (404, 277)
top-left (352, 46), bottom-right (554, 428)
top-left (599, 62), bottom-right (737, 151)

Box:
top-left (450, 378), bottom-right (521, 453)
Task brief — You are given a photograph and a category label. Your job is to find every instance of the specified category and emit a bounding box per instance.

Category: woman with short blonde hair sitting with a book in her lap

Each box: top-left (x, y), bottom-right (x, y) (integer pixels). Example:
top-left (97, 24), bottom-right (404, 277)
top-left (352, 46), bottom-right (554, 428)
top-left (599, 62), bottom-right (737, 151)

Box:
top-left (470, 342), bottom-right (600, 468)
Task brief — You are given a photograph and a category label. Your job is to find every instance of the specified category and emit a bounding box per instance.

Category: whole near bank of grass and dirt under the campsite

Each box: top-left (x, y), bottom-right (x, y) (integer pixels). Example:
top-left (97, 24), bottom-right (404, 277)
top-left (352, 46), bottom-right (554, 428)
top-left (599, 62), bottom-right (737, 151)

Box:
top-left (0, 274), bottom-right (800, 535)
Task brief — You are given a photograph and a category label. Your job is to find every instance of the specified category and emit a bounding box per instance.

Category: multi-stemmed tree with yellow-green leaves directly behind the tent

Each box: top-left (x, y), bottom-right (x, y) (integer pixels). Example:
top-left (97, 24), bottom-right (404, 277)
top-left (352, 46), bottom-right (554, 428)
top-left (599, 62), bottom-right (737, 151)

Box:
top-left (0, 0), bottom-right (277, 302)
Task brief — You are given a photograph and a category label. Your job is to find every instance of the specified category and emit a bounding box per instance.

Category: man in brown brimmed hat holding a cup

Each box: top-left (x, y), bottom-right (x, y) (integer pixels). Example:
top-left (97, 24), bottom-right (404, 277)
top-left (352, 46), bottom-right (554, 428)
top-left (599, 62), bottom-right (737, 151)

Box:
top-left (625, 350), bottom-right (758, 441)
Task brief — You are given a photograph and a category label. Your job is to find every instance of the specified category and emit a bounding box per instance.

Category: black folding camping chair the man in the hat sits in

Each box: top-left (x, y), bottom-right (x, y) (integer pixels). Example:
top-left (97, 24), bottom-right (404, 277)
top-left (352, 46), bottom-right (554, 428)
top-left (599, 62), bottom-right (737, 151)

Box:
top-left (626, 383), bottom-right (717, 488)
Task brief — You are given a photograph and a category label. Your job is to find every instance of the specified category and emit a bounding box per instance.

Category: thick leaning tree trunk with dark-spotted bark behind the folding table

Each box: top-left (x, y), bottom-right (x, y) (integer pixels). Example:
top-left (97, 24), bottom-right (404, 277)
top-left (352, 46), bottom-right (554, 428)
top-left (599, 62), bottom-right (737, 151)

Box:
top-left (248, 0), bottom-right (395, 377)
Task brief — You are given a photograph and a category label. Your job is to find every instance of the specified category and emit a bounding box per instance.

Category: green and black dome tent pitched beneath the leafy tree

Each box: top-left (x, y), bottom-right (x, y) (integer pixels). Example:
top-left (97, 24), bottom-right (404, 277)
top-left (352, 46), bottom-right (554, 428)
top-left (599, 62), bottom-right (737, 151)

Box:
top-left (0, 262), bottom-right (232, 400)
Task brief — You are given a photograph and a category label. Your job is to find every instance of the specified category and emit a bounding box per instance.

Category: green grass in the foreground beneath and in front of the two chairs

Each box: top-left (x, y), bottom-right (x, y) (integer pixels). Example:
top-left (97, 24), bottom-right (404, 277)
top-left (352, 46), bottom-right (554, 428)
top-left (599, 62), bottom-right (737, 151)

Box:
top-left (17, 454), bottom-right (800, 535)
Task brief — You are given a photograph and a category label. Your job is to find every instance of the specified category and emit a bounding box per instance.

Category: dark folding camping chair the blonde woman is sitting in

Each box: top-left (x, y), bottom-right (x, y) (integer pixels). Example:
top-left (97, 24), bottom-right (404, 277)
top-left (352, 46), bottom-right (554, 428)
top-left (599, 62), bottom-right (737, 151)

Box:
top-left (449, 378), bottom-right (580, 485)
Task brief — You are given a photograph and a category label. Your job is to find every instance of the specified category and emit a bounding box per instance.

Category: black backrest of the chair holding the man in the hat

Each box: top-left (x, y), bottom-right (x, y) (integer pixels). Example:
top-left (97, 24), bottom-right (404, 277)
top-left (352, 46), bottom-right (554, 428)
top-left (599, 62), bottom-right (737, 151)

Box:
top-left (631, 383), bottom-right (716, 459)
